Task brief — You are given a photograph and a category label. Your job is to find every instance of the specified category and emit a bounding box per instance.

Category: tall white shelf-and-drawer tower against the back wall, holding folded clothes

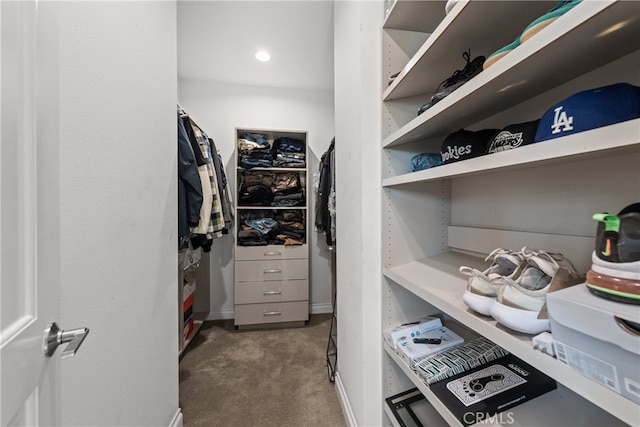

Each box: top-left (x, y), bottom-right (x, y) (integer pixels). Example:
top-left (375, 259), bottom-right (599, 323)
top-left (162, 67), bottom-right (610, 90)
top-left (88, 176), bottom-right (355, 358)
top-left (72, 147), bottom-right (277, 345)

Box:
top-left (234, 128), bottom-right (309, 328)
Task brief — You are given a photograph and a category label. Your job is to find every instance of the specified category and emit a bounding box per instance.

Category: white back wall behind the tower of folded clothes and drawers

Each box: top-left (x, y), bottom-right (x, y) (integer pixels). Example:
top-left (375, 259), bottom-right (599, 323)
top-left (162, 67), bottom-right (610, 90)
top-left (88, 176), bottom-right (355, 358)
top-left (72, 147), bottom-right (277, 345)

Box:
top-left (178, 80), bottom-right (334, 319)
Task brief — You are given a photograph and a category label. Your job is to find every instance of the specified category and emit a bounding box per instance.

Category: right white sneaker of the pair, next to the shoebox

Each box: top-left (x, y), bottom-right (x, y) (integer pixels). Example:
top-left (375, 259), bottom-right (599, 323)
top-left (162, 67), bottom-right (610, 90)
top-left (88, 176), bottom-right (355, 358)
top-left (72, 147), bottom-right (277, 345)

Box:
top-left (491, 251), bottom-right (584, 334)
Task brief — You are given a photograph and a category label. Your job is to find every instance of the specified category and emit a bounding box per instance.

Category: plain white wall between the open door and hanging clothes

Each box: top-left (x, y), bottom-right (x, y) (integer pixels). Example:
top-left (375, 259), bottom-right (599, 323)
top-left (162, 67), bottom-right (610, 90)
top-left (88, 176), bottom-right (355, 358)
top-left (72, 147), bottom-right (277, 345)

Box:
top-left (59, 1), bottom-right (180, 426)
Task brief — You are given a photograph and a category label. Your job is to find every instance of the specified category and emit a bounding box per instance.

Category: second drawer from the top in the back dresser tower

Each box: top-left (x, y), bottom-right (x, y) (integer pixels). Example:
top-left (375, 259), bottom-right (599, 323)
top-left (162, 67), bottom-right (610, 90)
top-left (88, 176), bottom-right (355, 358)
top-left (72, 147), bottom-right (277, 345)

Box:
top-left (235, 259), bottom-right (309, 282)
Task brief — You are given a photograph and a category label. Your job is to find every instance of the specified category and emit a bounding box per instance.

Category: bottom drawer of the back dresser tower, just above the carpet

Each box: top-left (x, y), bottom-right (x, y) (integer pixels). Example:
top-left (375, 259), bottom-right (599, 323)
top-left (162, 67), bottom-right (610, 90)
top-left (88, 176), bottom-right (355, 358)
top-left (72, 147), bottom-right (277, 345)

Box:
top-left (234, 301), bottom-right (309, 325)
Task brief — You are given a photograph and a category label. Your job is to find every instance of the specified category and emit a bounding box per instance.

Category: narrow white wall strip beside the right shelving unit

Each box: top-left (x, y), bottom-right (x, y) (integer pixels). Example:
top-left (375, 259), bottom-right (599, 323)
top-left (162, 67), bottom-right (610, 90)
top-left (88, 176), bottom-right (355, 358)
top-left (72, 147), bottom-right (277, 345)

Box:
top-left (334, 1), bottom-right (383, 426)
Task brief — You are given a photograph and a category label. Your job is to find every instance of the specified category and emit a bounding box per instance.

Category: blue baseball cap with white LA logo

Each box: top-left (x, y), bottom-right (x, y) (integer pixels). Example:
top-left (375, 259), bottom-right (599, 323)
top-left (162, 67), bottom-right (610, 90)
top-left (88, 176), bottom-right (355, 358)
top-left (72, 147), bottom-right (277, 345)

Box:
top-left (535, 83), bottom-right (640, 142)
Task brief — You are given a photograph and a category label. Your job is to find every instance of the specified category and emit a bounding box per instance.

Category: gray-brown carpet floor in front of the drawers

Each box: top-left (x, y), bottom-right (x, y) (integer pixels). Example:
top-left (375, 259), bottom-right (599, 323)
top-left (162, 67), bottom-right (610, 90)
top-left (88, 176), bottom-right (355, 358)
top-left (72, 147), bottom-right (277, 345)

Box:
top-left (180, 314), bottom-right (345, 427)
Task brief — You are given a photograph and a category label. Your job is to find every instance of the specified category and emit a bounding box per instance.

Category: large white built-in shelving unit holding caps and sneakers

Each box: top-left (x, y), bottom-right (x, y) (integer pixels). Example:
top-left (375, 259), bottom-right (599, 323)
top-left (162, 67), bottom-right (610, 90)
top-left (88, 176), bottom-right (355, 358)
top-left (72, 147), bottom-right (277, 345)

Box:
top-left (381, 0), bottom-right (640, 426)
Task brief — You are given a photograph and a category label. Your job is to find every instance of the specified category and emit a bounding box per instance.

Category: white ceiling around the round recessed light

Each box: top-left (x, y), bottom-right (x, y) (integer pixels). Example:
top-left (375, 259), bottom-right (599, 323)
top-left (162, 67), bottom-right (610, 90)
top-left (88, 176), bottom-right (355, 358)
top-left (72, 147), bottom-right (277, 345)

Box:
top-left (178, 0), bottom-right (333, 90)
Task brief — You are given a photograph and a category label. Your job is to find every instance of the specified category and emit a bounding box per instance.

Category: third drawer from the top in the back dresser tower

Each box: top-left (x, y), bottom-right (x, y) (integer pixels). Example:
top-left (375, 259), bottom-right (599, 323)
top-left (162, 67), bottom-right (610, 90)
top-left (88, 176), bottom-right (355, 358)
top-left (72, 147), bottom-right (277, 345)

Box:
top-left (234, 280), bottom-right (309, 304)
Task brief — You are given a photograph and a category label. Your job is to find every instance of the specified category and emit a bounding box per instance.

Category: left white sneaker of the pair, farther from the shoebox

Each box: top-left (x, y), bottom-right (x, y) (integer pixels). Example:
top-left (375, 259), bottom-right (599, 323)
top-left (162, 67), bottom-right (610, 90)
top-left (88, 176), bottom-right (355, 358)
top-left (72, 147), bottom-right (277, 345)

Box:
top-left (460, 248), bottom-right (525, 316)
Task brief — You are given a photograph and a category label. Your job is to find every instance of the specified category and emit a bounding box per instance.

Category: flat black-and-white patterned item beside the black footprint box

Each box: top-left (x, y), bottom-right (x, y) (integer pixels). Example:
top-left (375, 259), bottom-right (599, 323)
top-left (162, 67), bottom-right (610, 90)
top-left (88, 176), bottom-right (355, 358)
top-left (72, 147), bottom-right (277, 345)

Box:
top-left (414, 337), bottom-right (509, 385)
